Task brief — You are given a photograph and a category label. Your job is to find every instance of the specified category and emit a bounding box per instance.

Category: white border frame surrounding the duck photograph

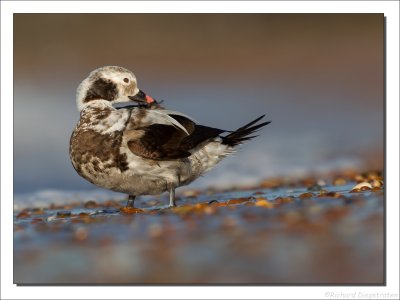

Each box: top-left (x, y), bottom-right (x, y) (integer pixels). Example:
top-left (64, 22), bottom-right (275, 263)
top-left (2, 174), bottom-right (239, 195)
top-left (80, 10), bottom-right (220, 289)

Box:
top-left (1, 1), bottom-right (400, 299)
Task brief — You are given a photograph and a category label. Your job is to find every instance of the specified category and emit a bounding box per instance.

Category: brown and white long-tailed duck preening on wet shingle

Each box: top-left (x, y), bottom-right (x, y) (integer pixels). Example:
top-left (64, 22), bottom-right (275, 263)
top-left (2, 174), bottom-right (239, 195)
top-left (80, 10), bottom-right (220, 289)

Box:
top-left (69, 66), bottom-right (270, 206)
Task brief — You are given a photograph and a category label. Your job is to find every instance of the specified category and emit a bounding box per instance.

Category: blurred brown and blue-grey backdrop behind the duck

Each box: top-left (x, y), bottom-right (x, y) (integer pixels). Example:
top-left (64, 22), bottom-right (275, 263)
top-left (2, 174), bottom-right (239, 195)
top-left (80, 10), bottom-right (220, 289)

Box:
top-left (14, 14), bottom-right (384, 203)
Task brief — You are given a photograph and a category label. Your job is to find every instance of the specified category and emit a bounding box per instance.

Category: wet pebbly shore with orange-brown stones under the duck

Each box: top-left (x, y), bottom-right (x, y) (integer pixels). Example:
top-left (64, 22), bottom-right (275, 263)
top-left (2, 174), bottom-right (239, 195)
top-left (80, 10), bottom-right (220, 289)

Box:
top-left (14, 171), bottom-right (384, 285)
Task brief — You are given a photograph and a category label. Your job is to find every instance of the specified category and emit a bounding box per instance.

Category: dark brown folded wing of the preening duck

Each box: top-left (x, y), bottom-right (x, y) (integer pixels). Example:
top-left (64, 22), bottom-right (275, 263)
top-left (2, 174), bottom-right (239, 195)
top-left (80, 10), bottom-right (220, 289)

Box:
top-left (124, 114), bottom-right (225, 160)
